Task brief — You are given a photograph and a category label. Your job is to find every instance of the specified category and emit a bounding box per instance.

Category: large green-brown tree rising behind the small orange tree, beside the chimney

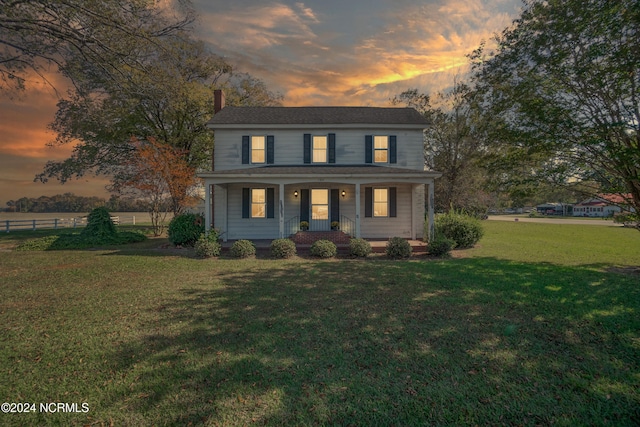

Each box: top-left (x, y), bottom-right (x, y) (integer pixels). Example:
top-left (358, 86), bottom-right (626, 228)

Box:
top-left (38, 34), bottom-right (231, 182)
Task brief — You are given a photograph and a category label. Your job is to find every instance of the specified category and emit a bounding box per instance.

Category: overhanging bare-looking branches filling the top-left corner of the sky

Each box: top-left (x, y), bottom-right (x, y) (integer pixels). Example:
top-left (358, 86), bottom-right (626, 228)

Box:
top-left (0, 0), bottom-right (193, 92)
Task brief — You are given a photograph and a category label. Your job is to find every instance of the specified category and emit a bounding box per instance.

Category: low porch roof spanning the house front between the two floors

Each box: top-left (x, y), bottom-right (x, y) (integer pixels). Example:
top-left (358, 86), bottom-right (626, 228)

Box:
top-left (198, 165), bottom-right (442, 183)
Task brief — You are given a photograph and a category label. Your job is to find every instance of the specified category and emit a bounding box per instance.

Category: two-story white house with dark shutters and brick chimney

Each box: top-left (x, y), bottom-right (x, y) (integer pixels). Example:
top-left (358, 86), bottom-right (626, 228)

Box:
top-left (198, 93), bottom-right (441, 241)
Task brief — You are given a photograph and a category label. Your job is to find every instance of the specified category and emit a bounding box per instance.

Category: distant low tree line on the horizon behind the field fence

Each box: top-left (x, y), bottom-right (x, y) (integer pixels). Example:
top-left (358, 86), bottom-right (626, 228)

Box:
top-left (0, 193), bottom-right (148, 213)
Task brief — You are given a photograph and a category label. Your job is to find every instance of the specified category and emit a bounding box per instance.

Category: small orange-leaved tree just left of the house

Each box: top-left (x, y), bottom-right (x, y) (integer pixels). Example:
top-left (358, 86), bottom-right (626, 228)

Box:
top-left (111, 137), bottom-right (198, 235)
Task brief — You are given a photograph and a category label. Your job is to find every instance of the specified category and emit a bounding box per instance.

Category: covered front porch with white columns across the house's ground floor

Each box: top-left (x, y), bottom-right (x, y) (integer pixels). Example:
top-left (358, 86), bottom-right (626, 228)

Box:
top-left (199, 166), bottom-right (440, 241)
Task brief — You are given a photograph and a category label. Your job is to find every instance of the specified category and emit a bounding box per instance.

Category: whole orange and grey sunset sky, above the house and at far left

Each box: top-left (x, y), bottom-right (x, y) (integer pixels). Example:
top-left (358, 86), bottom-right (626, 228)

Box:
top-left (0, 0), bottom-right (522, 207)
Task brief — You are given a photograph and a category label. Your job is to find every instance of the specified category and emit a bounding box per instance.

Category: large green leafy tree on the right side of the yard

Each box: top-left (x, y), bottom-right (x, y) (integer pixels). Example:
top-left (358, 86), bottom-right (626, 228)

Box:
top-left (471, 0), bottom-right (640, 226)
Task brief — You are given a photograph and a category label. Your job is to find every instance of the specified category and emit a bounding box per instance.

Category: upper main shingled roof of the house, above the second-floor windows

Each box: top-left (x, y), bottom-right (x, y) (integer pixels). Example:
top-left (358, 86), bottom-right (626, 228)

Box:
top-left (208, 107), bottom-right (429, 128)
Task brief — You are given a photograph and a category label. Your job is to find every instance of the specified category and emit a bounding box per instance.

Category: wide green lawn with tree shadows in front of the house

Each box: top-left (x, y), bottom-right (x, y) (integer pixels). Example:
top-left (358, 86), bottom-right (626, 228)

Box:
top-left (0, 222), bottom-right (640, 426)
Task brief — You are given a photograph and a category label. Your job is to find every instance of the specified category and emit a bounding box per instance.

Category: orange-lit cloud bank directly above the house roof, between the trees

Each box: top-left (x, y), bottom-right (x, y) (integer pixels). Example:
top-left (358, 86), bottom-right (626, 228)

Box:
top-left (196, 0), bottom-right (518, 106)
